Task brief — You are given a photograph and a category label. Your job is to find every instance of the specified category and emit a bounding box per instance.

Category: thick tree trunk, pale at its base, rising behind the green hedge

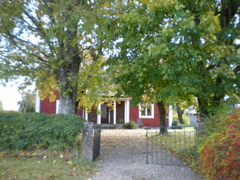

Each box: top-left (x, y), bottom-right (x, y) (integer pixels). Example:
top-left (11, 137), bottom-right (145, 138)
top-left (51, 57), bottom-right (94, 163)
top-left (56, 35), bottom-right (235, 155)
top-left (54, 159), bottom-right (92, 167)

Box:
top-left (55, 1), bottom-right (82, 114)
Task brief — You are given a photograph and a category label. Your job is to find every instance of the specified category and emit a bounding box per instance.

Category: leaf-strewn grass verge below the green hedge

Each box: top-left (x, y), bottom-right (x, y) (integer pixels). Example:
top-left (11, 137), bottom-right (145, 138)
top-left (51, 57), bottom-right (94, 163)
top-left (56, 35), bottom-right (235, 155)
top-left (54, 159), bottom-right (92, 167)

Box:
top-left (0, 136), bottom-right (97, 180)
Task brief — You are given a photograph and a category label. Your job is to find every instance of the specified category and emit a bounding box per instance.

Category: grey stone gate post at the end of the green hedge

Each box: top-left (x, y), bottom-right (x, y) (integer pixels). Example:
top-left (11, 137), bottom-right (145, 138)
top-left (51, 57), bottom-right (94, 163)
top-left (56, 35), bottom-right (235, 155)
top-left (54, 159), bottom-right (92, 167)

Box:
top-left (82, 122), bottom-right (94, 161)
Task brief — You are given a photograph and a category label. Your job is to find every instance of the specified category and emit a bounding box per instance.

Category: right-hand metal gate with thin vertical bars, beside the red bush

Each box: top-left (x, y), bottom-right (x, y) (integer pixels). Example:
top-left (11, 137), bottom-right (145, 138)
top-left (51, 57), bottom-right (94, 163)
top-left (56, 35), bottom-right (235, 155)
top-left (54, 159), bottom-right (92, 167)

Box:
top-left (146, 126), bottom-right (196, 166)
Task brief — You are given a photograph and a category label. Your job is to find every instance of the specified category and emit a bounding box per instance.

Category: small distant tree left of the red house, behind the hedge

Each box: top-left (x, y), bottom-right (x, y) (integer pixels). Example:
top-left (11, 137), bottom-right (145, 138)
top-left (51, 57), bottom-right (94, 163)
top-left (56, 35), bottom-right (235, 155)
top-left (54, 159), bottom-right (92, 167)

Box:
top-left (18, 90), bottom-right (36, 113)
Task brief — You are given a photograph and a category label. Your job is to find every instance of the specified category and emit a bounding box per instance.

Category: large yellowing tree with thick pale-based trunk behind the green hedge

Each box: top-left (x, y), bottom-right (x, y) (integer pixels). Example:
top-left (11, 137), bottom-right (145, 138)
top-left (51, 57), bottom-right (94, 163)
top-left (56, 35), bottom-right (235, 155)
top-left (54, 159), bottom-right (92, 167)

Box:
top-left (0, 0), bottom-right (116, 114)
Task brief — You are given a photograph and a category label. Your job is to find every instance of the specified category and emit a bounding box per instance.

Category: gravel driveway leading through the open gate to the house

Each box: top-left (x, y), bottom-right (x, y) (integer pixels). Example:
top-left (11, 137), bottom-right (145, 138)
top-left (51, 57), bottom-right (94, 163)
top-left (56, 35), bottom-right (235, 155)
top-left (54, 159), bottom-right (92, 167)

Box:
top-left (89, 129), bottom-right (203, 180)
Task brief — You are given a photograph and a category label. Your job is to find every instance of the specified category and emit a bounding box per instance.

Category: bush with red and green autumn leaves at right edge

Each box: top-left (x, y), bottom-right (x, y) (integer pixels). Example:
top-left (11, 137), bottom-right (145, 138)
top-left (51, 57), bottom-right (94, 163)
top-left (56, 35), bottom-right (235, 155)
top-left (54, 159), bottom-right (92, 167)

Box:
top-left (199, 110), bottom-right (240, 180)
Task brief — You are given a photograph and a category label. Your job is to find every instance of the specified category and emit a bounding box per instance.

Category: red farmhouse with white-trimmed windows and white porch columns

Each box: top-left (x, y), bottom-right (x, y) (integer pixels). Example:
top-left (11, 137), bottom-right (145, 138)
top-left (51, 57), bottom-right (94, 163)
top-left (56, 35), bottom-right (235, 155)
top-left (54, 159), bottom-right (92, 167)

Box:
top-left (36, 93), bottom-right (172, 127)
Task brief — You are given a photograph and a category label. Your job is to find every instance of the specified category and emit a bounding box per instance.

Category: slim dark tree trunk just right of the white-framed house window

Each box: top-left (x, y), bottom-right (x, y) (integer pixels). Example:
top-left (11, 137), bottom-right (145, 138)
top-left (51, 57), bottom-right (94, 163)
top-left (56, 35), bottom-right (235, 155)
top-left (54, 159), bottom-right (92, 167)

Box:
top-left (157, 101), bottom-right (167, 133)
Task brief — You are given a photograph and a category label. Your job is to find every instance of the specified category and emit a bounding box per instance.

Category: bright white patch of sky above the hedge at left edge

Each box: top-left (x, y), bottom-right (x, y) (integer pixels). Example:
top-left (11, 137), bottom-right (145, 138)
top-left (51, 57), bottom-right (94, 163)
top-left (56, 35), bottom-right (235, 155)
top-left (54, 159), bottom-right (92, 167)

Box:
top-left (0, 81), bottom-right (35, 111)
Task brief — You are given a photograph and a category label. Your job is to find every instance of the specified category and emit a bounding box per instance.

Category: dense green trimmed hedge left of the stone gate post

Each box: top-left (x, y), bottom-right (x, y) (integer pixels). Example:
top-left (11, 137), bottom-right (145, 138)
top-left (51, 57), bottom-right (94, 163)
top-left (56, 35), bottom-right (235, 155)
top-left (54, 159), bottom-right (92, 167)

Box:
top-left (0, 113), bottom-right (84, 150)
